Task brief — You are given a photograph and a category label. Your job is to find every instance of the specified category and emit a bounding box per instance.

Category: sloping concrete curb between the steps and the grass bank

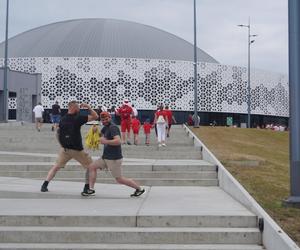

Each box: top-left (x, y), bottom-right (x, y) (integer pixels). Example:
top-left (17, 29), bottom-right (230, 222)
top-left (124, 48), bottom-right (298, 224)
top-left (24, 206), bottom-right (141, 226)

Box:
top-left (184, 125), bottom-right (300, 250)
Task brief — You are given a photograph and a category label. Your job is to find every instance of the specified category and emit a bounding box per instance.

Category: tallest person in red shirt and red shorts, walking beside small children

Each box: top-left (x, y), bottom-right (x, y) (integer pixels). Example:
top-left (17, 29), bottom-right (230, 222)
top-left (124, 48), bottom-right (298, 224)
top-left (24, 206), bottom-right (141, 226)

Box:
top-left (116, 99), bottom-right (133, 145)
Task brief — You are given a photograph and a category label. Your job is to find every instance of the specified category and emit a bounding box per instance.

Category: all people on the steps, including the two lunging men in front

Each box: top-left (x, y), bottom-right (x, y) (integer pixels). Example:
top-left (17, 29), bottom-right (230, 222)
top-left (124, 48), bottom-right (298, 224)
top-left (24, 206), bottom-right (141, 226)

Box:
top-left (38, 99), bottom-right (176, 197)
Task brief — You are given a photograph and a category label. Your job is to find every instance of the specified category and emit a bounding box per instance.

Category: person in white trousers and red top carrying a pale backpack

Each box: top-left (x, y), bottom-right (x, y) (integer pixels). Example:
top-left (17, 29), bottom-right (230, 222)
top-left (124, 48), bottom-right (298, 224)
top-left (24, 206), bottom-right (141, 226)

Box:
top-left (154, 105), bottom-right (169, 147)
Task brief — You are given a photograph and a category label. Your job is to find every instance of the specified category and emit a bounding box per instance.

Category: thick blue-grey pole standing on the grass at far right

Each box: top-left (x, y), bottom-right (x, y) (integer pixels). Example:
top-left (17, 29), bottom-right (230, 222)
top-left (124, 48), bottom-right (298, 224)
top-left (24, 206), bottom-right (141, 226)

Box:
top-left (284, 0), bottom-right (300, 207)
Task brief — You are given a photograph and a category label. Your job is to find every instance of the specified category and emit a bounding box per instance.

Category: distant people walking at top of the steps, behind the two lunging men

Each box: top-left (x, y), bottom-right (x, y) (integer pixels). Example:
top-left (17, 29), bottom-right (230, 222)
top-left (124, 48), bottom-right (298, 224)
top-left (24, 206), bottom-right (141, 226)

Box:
top-left (33, 99), bottom-right (176, 147)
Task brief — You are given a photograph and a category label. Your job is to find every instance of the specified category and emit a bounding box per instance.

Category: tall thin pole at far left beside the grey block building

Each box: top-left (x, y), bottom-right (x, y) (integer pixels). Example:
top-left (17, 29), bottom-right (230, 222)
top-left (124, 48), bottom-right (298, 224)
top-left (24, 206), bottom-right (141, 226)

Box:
top-left (3, 0), bottom-right (9, 122)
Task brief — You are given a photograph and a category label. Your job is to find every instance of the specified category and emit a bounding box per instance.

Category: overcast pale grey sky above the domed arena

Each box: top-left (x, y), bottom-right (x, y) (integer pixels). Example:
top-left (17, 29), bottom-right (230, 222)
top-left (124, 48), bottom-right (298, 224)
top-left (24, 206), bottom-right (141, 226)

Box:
top-left (0, 0), bottom-right (288, 74)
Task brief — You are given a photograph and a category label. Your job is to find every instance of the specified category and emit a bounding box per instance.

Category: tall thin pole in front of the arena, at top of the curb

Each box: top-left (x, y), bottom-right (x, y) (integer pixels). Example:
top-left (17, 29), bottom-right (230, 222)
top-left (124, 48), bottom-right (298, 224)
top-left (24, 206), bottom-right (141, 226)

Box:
top-left (194, 0), bottom-right (199, 128)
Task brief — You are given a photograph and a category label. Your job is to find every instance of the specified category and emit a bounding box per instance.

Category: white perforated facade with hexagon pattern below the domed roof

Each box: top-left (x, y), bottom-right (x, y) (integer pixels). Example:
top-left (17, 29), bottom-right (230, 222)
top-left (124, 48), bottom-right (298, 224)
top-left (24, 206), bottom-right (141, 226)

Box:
top-left (1, 57), bottom-right (289, 117)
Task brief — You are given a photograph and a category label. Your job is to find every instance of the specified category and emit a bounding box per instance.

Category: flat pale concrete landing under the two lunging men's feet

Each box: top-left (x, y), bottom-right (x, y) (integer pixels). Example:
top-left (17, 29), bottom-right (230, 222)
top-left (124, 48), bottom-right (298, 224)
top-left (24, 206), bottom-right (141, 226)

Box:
top-left (0, 177), bottom-right (253, 216)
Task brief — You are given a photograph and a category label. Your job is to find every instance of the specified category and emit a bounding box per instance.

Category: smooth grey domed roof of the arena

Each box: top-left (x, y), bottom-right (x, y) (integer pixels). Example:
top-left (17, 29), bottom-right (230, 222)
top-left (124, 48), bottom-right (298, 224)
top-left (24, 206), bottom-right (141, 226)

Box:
top-left (0, 18), bottom-right (218, 63)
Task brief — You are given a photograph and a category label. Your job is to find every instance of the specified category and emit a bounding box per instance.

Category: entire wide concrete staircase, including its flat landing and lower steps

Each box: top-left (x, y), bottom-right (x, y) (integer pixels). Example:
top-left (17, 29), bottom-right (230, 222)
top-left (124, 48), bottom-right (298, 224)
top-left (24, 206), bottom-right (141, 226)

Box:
top-left (0, 124), bottom-right (264, 250)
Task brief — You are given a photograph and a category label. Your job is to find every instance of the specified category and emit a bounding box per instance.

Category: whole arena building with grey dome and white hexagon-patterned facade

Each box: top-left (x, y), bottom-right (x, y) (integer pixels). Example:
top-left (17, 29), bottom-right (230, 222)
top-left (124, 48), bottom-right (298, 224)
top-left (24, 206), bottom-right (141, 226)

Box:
top-left (0, 19), bottom-right (289, 126)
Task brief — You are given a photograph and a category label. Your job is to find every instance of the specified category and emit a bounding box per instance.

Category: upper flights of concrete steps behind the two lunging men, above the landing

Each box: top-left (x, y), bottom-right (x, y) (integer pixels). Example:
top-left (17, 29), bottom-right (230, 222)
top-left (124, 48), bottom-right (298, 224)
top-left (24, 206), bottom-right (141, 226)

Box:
top-left (0, 126), bottom-right (218, 186)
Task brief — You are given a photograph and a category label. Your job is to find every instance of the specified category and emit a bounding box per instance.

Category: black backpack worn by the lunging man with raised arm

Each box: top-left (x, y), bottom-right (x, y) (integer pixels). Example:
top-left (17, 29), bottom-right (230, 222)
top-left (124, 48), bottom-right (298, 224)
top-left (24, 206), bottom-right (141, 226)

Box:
top-left (58, 115), bottom-right (76, 149)
